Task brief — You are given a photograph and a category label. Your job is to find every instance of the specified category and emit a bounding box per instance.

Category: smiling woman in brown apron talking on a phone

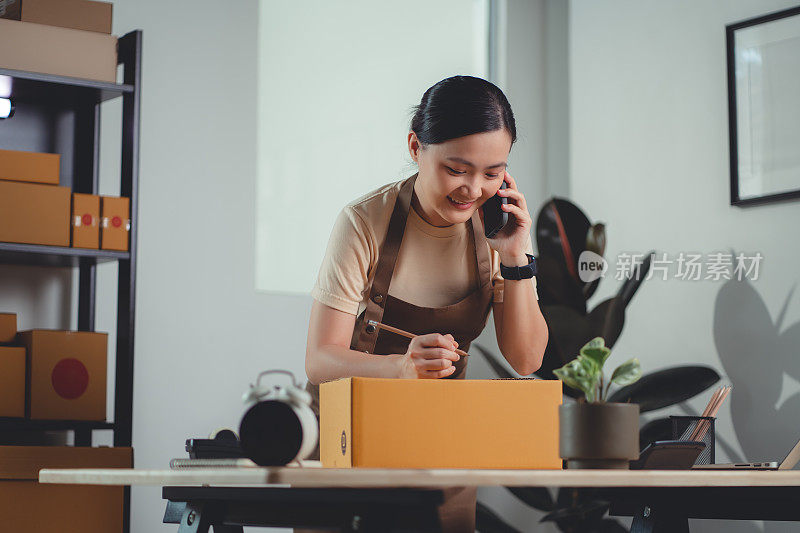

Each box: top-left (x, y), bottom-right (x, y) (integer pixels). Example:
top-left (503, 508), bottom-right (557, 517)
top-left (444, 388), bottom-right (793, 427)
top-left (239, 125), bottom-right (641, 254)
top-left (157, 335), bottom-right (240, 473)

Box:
top-left (306, 76), bottom-right (547, 531)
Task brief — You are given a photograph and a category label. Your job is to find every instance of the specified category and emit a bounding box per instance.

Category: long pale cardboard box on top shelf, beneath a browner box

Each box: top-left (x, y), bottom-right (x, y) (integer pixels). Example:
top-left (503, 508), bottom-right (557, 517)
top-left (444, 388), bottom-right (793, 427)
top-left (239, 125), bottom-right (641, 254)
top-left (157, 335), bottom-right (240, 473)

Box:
top-left (0, 19), bottom-right (117, 83)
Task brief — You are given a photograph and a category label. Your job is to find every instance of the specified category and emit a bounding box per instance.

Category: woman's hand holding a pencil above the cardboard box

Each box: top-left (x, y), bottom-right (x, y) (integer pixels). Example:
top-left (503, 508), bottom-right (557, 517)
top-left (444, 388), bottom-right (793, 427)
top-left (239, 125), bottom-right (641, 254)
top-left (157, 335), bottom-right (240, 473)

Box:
top-left (398, 333), bottom-right (461, 379)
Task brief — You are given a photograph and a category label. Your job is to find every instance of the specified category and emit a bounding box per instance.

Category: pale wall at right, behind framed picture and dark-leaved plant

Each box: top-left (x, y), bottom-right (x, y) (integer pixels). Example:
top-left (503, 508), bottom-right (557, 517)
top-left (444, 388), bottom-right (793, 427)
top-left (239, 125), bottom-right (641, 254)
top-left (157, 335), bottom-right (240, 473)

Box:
top-left (569, 0), bottom-right (800, 532)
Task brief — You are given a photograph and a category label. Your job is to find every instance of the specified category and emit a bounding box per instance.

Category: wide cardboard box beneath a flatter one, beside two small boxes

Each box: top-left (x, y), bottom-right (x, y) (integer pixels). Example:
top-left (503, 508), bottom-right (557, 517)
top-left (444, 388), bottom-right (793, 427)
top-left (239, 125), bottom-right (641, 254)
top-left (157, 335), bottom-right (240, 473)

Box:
top-left (0, 179), bottom-right (70, 246)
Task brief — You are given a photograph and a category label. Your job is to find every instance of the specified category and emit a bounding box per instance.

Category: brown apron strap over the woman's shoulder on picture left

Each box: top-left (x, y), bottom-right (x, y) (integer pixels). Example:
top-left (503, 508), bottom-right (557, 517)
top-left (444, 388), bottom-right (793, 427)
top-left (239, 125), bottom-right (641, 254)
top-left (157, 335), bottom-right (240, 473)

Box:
top-left (356, 174), bottom-right (417, 353)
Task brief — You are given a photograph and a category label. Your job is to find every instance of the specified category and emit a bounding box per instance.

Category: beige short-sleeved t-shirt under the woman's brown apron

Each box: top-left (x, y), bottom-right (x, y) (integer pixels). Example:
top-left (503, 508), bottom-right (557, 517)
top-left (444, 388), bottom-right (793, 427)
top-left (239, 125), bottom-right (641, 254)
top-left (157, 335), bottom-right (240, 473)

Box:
top-left (311, 181), bottom-right (539, 315)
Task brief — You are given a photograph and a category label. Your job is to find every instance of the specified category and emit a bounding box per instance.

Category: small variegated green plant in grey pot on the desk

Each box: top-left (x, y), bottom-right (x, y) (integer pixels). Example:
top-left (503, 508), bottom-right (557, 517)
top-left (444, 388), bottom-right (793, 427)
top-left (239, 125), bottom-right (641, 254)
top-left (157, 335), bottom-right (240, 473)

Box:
top-left (553, 337), bottom-right (642, 468)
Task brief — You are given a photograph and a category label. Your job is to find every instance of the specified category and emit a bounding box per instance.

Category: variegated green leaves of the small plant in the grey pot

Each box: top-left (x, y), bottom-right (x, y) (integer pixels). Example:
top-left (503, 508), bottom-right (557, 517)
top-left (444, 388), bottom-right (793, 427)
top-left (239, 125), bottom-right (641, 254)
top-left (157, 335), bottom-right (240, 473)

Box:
top-left (553, 337), bottom-right (642, 402)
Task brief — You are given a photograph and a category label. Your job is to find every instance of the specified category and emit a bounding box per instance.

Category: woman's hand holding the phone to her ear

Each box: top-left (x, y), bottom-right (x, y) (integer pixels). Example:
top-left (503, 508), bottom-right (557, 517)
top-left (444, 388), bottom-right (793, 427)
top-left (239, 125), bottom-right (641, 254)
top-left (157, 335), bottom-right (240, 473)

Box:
top-left (488, 171), bottom-right (532, 266)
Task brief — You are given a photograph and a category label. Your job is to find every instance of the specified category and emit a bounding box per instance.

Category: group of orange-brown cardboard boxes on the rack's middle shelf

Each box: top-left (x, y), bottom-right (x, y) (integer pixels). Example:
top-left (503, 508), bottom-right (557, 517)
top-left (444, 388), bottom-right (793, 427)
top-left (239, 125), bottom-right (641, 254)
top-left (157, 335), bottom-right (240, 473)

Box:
top-left (0, 149), bottom-right (131, 251)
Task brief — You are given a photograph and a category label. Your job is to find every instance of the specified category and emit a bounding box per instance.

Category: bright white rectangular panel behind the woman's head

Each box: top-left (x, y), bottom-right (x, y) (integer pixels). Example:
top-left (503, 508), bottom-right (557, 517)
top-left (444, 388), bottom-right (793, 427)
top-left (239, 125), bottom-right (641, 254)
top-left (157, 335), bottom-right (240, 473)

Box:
top-left (255, 0), bottom-right (488, 294)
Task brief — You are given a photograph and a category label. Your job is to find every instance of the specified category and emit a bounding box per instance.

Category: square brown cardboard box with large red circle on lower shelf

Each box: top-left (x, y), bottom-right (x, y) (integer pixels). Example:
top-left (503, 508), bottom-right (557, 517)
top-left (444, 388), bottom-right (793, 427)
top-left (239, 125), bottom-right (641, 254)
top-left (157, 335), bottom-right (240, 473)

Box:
top-left (19, 329), bottom-right (108, 420)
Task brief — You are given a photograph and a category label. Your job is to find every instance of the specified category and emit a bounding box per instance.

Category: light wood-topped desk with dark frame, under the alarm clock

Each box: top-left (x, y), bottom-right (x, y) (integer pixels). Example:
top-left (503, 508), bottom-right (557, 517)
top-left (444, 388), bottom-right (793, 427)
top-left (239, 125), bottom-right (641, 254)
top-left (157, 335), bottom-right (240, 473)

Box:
top-left (39, 467), bottom-right (800, 533)
